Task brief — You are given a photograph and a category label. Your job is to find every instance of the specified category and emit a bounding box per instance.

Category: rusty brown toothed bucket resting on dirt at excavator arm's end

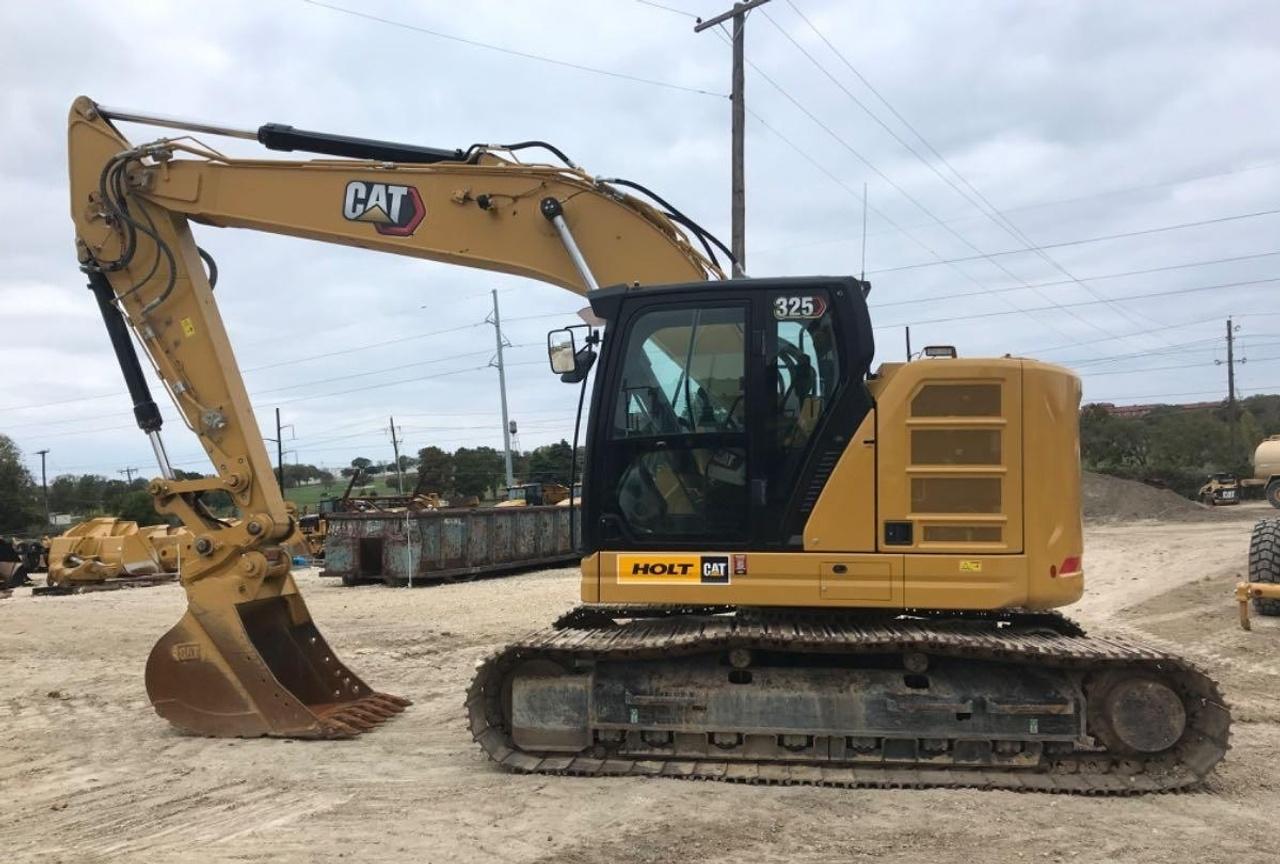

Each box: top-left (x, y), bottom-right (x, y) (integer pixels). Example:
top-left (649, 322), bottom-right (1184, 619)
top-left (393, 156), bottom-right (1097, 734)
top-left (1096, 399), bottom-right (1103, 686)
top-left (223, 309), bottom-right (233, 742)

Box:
top-left (146, 576), bottom-right (410, 739)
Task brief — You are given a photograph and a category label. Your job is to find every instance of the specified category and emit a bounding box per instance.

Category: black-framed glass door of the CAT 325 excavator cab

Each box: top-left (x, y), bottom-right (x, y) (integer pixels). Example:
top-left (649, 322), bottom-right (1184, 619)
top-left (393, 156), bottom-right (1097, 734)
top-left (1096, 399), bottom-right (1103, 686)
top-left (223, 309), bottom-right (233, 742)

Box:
top-left (591, 300), bottom-right (759, 549)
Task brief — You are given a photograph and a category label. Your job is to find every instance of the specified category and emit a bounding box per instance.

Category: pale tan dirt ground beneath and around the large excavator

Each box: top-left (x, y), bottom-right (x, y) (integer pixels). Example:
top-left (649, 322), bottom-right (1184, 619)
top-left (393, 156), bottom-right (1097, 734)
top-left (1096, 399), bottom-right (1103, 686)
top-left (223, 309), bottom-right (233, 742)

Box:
top-left (0, 504), bottom-right (1280, 864)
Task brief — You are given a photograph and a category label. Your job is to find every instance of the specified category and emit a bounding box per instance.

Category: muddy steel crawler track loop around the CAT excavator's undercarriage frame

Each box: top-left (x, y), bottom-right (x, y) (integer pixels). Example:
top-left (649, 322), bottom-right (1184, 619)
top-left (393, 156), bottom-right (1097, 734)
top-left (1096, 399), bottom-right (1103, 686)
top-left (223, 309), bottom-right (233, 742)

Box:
top-left (467, 607), bottom-right (1230, 795)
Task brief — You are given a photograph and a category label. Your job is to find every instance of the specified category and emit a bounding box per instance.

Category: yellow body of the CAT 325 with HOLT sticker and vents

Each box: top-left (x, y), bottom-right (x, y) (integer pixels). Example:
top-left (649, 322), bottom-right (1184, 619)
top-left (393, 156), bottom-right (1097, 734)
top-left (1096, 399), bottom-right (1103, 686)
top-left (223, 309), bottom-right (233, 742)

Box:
top-left (581, 358), bottom-right (1084, 609)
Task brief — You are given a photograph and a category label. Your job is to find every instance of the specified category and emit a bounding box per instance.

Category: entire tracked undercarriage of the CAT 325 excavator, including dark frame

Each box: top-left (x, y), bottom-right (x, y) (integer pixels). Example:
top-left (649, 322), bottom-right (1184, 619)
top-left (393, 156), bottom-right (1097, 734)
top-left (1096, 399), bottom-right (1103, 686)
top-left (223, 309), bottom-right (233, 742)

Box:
top-left (467, 607), bottom-right (1230, 794)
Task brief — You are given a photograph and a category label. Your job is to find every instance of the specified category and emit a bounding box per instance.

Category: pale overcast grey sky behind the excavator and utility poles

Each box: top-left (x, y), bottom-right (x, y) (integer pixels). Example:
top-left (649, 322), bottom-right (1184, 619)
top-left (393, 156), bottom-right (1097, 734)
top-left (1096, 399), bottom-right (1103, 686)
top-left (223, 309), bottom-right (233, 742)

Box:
top-left (0, 0), bottom-right (1280, 476)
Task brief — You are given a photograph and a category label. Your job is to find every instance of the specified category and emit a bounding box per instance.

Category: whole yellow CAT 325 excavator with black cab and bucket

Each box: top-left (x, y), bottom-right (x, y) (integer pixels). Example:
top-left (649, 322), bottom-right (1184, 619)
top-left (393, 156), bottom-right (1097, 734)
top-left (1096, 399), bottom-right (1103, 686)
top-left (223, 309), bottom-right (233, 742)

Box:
top-left (69, 97), bottom-right (1230, 794)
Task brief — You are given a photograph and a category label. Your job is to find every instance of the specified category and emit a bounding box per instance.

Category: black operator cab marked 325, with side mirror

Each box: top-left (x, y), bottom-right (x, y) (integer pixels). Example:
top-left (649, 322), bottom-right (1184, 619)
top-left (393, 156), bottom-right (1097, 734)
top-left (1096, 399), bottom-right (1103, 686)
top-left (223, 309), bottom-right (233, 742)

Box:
top-left (548, 276), bottom-right (874, 552)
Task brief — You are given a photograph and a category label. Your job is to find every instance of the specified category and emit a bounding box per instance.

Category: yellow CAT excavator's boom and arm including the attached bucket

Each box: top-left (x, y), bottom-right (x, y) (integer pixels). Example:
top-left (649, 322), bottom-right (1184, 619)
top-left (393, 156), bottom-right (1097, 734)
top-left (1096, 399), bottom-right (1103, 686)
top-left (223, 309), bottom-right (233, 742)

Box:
top-left (68, 97), bottom-right (723, 737)
